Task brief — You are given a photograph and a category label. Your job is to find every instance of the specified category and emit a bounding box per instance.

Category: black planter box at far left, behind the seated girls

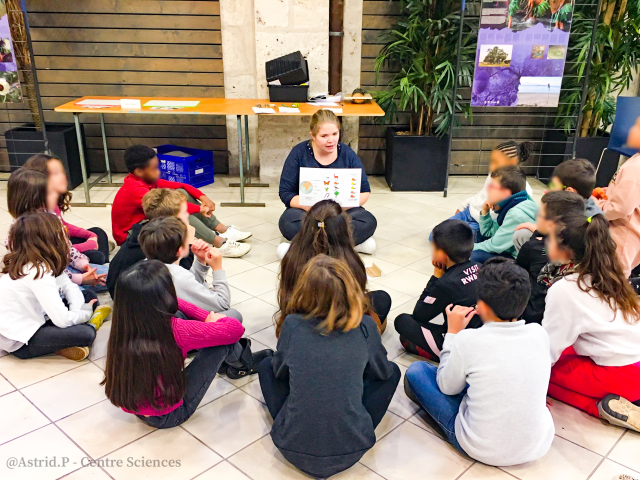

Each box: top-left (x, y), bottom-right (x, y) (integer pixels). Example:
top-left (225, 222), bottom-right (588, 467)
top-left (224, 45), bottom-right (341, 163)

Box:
top-left (4, 123), bottom-right (84, 190)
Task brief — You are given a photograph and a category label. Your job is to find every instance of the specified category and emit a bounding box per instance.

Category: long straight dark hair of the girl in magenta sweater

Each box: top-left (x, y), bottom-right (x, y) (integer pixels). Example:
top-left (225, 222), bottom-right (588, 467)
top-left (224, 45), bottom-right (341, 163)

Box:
top-left (101, 260), bottom-right (186, 412)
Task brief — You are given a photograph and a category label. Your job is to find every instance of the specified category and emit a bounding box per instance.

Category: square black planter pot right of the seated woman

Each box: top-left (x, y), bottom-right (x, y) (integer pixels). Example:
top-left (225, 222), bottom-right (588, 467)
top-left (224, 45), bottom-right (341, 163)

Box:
top-left (384, 127), bottom-right (449, 192)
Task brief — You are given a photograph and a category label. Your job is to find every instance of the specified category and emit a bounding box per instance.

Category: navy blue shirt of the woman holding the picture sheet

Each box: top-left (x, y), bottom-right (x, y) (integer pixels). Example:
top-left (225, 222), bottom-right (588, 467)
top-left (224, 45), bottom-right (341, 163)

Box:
top-left (279, 140), bottom-right (371, 208)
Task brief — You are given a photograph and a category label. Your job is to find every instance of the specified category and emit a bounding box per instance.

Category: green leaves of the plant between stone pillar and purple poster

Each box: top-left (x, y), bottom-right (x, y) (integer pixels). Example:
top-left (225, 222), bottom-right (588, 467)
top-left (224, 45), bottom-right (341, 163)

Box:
top-left (372, 0), bottom-right (475, 135)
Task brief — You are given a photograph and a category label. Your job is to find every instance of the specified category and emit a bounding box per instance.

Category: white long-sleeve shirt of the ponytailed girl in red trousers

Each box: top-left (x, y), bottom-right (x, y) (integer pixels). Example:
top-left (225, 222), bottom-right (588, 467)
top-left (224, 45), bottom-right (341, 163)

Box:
top-left (542, 273), bottom-right (640, 367)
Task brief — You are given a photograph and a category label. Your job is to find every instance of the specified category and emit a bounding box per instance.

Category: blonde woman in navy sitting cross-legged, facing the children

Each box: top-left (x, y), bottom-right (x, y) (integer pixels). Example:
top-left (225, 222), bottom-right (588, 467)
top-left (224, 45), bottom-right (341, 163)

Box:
top-left (278, 110), bottom-right (378, 258)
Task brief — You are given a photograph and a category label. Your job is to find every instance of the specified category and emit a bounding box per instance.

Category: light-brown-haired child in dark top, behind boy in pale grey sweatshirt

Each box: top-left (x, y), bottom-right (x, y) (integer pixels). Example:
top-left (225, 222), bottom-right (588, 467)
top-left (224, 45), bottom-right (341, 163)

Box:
top-left (107, 188), bottom-right (193, 298)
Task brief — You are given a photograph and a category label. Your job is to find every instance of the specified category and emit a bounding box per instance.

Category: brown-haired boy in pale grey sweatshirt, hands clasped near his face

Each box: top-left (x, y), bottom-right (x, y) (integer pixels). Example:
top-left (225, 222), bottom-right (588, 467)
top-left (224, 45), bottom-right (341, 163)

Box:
top-left (138, 217), bottom-right (242, 322)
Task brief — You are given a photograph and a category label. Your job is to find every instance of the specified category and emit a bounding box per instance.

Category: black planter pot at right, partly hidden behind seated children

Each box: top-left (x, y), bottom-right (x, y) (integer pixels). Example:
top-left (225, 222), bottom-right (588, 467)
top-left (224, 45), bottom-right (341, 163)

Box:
top-left (536, 130), bottom-right (620, 187)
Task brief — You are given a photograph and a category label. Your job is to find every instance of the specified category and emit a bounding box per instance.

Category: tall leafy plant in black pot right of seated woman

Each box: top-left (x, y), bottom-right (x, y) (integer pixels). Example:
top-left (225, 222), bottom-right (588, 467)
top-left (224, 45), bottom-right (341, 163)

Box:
top-left (372, 0), bottom-right (475, 191)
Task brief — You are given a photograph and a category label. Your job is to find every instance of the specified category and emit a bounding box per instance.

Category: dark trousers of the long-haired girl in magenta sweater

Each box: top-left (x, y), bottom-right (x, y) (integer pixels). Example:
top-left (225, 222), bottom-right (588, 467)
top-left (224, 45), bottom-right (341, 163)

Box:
top-left (136, 343), bottom-right (242, 428)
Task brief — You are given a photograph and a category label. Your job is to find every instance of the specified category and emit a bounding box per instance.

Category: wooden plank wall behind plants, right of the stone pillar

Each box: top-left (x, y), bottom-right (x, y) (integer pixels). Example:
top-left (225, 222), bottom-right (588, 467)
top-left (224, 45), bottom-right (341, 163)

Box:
top-left (359, 0), bottom-right (553, 175)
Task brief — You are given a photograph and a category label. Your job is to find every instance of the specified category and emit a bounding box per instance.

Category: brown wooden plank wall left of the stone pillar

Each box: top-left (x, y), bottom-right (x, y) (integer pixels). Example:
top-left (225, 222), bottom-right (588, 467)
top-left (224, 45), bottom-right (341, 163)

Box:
top-left (0, 0), bottom-right (228, 173)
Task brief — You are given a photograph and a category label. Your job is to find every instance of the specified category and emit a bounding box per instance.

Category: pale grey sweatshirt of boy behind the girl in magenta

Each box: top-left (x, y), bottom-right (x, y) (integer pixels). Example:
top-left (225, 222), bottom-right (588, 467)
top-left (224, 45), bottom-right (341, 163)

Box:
top-left (166, 258), bottom-right (231, 313)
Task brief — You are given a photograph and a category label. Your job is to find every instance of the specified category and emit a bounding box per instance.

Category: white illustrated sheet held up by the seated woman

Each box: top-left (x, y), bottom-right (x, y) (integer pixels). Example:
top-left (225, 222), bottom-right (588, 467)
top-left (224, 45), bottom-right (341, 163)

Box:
top-left (299, 167), bottom-right (362, 207)
